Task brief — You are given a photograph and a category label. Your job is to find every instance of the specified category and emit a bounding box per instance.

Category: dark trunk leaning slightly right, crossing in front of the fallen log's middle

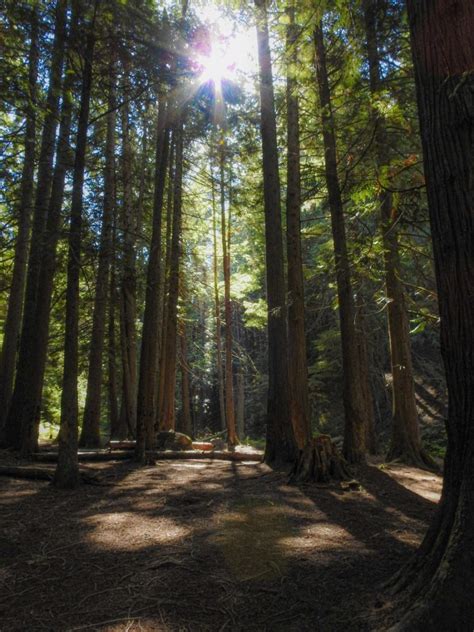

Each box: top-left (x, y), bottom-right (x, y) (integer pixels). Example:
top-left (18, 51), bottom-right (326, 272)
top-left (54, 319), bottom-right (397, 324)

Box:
top-left (136, 95), bottom-right (169, 461)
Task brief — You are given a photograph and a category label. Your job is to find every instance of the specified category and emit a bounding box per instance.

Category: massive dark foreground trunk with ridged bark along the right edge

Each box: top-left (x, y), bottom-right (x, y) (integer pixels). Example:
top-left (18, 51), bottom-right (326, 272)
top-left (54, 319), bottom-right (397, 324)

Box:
top-left (386, 0), bottom-right (474, 632)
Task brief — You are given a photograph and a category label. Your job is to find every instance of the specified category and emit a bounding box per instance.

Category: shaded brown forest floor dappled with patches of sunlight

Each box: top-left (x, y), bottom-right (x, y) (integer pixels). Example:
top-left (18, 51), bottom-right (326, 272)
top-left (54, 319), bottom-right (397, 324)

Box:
top-left (0, 452), bottom-right (441, 632)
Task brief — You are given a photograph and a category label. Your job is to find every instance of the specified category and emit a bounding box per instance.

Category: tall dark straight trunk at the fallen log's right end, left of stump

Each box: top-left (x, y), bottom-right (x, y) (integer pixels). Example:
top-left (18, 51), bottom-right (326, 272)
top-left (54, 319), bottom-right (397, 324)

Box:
top-left (255, 0), bottom-right (297, 463)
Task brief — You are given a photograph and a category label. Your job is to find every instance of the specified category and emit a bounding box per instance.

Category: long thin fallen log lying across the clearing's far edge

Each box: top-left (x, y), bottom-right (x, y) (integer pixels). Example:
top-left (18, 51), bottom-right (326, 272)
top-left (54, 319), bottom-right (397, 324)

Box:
top-left (34, 450), bottom-right (262, 463)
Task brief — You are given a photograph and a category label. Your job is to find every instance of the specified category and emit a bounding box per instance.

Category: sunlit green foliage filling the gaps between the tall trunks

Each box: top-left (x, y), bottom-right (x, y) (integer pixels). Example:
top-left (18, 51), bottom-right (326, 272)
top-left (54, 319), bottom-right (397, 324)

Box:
top-left (0, 0), bottom-right (439, 449)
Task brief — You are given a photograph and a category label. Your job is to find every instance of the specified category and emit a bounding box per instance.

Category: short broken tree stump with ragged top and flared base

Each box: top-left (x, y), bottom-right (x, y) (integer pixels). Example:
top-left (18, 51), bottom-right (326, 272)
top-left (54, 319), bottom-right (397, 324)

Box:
top-left (290, 435), bottom-right (352, 483)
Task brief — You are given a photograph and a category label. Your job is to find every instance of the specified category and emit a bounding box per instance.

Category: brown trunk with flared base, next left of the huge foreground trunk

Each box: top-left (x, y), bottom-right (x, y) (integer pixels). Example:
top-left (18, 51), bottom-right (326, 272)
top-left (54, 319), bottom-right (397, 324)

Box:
top-left (364, 0), bottom-right (433, 467)
